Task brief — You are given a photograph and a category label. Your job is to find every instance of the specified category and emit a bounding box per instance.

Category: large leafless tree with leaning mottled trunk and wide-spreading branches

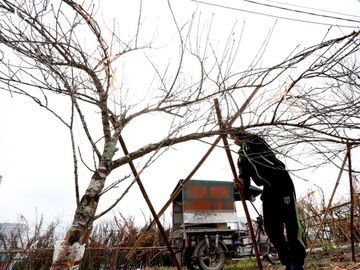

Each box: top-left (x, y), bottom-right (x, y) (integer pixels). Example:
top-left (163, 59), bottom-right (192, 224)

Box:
top-left (0, 0), bottom-right (360, 269)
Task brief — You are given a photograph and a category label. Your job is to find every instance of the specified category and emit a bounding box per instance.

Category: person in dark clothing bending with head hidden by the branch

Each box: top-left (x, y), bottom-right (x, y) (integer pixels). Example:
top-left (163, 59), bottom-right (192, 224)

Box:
top-left (231, 131), bottom-right (306, 270)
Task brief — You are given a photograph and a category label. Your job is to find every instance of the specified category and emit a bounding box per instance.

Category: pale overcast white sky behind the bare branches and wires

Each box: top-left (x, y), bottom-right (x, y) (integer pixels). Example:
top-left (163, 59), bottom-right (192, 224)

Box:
top-left (0, 0), bottom-right (360, 228)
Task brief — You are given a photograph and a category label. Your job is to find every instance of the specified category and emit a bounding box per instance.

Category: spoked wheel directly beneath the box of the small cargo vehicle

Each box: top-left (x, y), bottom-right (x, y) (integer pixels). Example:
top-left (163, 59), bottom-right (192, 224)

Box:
top-left (195, 241), bottom-right (225, 270)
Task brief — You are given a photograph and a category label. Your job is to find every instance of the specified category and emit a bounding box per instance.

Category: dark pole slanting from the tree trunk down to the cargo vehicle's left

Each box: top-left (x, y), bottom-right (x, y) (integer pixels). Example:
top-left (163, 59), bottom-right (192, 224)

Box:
top-left (119, 135), bottom-right (181, 270)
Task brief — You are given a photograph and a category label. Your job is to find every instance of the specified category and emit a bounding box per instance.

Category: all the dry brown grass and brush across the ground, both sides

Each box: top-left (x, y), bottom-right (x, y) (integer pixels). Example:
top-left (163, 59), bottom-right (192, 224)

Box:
top-left (0, 178), bottom-right (360, 270)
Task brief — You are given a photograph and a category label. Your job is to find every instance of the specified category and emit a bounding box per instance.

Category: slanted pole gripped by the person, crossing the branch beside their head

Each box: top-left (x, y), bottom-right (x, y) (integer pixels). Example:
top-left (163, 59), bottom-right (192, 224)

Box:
top-left (214, 99), bottom-right (263, 270)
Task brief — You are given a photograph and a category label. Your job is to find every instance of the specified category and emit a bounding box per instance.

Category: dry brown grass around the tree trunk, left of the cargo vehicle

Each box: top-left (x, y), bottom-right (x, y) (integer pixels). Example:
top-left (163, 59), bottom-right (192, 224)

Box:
top-left (0, 214), bottom-right (168, 270)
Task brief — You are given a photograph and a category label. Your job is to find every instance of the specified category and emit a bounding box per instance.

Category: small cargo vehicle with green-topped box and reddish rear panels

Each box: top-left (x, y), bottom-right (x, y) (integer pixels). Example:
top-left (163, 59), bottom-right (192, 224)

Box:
top-left (171, 179), bottom-right (277, 270)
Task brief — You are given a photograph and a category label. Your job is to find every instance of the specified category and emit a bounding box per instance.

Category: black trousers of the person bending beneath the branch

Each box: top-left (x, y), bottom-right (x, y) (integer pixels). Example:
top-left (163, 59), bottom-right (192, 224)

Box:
top-left (263, 194), bottom-right (306, 265)
